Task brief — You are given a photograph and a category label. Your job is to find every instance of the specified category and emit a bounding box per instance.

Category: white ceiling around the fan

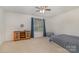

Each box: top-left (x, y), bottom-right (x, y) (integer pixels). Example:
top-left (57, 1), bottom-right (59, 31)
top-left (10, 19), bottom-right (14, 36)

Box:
top-left (0, 6), bottom-right (79, 17)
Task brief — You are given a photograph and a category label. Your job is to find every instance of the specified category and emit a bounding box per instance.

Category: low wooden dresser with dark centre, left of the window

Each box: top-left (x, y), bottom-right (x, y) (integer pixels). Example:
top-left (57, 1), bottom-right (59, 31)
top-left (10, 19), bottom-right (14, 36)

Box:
top-left (13, 31), bottom-right (31, 41)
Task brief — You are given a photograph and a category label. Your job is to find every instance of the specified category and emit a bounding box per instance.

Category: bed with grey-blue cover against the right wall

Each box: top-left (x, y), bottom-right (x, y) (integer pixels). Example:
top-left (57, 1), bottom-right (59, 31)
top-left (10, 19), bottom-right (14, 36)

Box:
top-left (49, 34), bottom-right (79, 53)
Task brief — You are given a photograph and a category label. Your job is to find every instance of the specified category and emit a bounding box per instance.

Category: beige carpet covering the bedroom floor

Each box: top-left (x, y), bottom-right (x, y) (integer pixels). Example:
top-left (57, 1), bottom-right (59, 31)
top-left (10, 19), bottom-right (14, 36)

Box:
top-left (0, 37), bottom-right (68, 53)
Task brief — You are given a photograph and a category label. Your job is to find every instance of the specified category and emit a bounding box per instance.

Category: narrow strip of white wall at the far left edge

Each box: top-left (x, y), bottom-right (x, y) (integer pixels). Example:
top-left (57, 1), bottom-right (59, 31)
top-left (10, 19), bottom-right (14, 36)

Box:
top-left (0, 8), bottom-right (5, 44)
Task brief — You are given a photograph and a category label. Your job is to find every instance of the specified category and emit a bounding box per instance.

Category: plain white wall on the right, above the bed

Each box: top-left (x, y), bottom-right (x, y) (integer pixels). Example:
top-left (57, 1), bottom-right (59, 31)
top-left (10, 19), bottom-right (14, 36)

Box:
top-left (47, 9), bottom-right (79, 36)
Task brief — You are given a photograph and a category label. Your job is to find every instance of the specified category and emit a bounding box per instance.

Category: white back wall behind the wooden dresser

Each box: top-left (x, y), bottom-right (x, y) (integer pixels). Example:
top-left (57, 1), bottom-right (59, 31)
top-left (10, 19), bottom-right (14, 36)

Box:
top-left (5, 12), bottom-right (41, 41)
